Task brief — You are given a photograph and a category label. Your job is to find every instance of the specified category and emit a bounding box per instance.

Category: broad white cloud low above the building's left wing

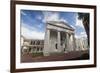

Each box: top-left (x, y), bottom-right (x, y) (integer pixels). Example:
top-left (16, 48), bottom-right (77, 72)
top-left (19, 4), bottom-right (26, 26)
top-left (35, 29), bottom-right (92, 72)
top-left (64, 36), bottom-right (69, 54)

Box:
top-left (21, 23), bottom-right (45, 39)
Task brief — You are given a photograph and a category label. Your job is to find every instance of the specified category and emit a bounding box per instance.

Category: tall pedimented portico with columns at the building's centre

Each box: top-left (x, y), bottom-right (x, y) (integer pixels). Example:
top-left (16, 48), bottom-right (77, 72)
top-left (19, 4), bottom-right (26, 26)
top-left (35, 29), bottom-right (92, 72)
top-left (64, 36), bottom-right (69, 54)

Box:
top-left (43, 21), bottom-right (75, 56)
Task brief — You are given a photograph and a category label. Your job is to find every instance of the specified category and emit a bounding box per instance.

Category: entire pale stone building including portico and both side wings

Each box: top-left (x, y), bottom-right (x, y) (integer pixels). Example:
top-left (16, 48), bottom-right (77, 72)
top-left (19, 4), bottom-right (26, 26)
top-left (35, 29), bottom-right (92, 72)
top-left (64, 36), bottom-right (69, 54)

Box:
top-left (21, 21), bottom-right (88, 56)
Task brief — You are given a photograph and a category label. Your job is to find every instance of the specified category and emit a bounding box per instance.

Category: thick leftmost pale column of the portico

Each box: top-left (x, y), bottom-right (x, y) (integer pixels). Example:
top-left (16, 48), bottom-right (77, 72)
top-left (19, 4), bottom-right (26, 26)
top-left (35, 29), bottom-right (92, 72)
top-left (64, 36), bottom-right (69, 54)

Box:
top-left (43, 29), bottom-right (50, 56)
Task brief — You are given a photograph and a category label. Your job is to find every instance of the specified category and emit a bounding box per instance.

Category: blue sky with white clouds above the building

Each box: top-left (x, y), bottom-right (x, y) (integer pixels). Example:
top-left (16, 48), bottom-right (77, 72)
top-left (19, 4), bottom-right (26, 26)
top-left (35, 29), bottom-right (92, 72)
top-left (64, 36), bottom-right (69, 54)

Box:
top-left (20, 10), bottom-right (86, 39)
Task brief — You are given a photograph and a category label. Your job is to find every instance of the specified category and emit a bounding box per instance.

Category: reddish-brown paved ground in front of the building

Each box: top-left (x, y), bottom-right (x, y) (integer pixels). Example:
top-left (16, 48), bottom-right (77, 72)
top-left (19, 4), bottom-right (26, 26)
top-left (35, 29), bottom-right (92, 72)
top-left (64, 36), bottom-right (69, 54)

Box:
top-left (21, 51), bottom-right (89, 62)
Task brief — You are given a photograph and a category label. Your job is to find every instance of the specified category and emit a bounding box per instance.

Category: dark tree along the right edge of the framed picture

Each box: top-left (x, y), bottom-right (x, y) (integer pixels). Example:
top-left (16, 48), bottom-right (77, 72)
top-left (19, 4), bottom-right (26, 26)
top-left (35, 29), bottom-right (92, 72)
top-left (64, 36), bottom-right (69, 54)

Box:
top-left (78, 13), bottom-right (90, 45)
